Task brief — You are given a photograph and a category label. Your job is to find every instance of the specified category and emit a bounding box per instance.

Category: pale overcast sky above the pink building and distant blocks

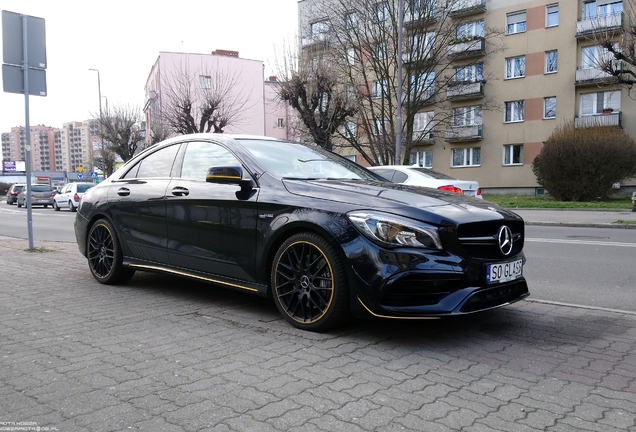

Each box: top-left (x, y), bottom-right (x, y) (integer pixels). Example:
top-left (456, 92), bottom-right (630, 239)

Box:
top-left (0, 0), bottom-right (298, 140)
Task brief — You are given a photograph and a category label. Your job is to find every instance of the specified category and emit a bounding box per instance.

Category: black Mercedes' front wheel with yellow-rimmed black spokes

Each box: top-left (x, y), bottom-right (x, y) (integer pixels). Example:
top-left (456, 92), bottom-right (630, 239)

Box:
top-left (271, 233), bottom-right (350, 332)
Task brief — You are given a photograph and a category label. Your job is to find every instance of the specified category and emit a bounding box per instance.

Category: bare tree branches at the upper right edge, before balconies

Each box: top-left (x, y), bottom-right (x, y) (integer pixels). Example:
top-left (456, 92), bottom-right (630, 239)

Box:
top-left (577, 0), bottom-right (636, 91)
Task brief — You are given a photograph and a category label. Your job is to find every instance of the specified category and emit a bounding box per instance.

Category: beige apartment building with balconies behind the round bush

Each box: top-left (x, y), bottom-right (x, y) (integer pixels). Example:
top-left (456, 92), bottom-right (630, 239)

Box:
top-left (298, 0), bottom-right (636, 194)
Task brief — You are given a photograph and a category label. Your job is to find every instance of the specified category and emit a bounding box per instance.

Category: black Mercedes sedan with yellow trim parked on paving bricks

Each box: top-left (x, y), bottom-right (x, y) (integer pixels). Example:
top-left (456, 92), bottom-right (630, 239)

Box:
top-left (75, 134), bottom-right (529, 331)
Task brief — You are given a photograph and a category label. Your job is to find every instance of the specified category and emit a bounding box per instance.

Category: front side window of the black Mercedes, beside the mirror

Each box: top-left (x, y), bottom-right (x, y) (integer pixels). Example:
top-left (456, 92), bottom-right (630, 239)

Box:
top-left (181, 142), bottom-right (241, 181)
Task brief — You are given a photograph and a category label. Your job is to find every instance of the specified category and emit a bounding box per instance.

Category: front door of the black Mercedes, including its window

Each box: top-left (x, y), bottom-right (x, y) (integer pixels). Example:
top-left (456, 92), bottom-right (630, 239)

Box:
top-left (166, 141), bottom-right (257, 281)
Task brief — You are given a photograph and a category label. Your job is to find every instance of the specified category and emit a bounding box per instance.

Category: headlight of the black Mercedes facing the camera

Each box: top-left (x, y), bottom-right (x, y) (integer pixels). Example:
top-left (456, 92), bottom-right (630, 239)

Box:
top-left (347, 211), bottom-right (442, 249)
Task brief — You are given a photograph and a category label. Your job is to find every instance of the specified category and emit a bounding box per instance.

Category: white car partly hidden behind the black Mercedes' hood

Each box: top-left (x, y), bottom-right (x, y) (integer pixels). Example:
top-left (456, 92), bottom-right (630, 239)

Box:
top-left (369, 165), bottom-right (483, 198)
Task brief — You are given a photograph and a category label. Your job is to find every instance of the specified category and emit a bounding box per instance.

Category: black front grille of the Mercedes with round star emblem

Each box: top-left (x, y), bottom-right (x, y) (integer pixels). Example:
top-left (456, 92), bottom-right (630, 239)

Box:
top-left (457, 220), bottom-right (524, 259)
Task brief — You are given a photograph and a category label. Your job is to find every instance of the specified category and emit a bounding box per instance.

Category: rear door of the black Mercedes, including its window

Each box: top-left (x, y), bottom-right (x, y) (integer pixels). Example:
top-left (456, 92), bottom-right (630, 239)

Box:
top-left (108, 143), bottom-right (180, 264)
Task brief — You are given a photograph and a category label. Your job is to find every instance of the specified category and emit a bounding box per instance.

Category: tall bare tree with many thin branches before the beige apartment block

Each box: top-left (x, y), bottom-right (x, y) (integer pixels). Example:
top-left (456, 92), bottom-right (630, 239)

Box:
top-left (290, 0), bottom-right (504, 165)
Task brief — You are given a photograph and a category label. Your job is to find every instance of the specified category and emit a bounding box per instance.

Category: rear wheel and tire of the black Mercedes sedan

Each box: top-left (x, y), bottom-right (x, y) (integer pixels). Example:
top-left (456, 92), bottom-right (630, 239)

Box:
top-left (86, 219), bottom-right (135, 285)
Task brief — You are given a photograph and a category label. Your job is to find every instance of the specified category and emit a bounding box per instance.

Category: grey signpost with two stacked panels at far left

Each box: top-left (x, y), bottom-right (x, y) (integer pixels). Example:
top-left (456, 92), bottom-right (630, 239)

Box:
top-left (2, 11), bottom-right (46, 249)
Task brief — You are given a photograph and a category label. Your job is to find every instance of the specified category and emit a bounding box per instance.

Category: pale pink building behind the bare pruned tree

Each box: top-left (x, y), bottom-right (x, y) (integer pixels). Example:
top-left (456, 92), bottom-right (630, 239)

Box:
top-left (144, 50), bottom-right (291, 139)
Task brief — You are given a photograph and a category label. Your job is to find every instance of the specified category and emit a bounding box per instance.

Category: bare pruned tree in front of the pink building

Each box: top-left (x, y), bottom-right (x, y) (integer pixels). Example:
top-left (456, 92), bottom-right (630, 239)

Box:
top-left (160, 61), bottom-right (255, 134)
